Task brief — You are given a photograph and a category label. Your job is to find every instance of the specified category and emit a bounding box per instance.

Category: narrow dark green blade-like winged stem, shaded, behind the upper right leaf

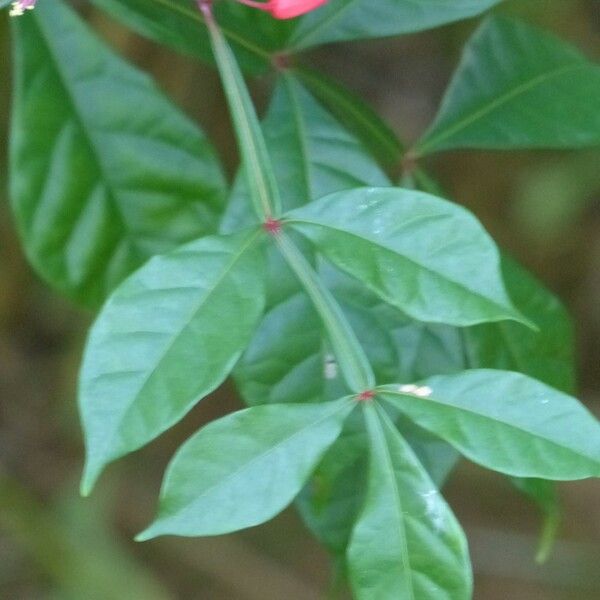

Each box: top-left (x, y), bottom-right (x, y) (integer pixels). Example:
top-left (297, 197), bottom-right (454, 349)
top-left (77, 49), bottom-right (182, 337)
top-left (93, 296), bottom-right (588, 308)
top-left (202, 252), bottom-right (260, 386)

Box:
top-left (293, 67), bottom-right (403, 176)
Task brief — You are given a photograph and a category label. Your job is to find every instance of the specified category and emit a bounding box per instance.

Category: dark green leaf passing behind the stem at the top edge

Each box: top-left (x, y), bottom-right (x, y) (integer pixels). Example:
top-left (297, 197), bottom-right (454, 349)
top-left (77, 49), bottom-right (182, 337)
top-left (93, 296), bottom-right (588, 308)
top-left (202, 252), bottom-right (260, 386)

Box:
top-left (91, 0), bottom-right (293, 74)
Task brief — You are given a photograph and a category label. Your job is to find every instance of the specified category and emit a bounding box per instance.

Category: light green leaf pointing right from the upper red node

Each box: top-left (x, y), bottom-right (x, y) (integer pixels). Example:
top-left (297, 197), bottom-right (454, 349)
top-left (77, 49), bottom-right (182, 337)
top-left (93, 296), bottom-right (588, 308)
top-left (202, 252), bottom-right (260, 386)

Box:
top-left (286, 188), bottom-right (527, 325)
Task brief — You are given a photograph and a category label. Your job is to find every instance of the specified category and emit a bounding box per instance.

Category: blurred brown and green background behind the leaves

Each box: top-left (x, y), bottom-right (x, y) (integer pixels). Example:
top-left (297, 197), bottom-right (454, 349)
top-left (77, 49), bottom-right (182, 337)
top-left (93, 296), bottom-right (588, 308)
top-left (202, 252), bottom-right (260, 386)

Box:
top-left (0, 0), bottom-right (600, 600)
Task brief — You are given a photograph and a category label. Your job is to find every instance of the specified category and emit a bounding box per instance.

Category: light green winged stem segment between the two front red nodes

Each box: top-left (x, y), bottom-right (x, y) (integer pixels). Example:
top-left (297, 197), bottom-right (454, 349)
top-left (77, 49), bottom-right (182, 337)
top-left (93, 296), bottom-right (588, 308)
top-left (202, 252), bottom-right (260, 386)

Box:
top-left (274, 232), bottom-right (375, 393)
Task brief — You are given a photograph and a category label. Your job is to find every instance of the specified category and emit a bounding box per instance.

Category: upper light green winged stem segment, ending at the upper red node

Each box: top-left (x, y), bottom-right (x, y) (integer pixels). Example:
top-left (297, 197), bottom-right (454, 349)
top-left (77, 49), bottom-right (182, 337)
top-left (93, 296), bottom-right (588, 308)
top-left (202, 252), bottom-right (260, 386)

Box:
top-left (197, 0), bottom-right (281, 220)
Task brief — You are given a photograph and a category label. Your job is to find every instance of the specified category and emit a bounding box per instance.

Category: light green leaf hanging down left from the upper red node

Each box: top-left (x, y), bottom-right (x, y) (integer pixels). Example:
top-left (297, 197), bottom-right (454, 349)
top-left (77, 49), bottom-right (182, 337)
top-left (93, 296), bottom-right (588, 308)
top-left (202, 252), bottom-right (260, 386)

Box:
top-left (79, 231), bottom-right (265, 493)
